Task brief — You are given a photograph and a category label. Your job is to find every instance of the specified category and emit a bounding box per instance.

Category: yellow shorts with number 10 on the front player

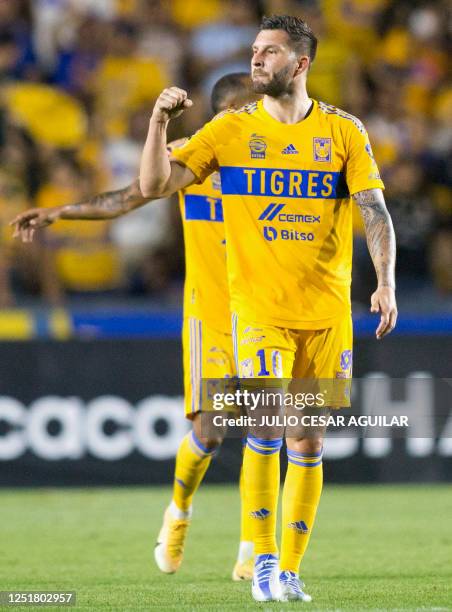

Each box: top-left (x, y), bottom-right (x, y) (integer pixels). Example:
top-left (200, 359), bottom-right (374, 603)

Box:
top-left (232, 314), bottom-right (353, 408)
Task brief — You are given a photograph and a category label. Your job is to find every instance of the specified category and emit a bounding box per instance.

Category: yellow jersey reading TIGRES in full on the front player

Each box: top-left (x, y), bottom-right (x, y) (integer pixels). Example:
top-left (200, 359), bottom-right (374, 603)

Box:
top-left (174, 100), bottom-right (384, 329)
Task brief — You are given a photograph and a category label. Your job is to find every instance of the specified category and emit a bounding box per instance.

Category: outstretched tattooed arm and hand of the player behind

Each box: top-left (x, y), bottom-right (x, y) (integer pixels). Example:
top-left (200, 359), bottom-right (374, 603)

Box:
top-left (10, 179), bottom-right (149, 242)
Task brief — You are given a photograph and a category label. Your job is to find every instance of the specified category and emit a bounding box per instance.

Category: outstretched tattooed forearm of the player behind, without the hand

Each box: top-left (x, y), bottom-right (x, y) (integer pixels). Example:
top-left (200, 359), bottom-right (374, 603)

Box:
top-left (61, 179), bottom-right (147, 219)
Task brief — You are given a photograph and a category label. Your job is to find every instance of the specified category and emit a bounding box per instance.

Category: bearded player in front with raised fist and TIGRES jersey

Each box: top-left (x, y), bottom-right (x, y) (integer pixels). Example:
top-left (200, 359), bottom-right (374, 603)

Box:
top-left (140, 15), bottom-right (397, 601)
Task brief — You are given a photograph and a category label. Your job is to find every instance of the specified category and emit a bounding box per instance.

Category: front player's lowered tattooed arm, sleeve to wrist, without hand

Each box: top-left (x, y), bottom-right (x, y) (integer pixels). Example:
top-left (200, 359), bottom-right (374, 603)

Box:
top-left (353, 189), bottom-right (396, 289)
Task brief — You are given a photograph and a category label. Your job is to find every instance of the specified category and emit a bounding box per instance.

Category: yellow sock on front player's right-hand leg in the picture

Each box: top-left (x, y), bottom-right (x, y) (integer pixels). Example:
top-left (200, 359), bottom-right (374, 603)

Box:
top-left (280, 450), bottom-right (323, 574)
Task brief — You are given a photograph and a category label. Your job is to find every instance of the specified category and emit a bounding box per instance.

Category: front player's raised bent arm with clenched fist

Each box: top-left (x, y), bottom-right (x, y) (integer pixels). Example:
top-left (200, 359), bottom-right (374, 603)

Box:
top-left (140, 87), bottom-right (197, 198)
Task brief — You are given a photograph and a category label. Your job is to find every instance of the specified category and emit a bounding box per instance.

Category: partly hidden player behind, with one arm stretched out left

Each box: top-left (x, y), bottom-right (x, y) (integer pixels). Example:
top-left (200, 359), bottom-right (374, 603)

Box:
top-left (11, 73), bottom-right (259, 580)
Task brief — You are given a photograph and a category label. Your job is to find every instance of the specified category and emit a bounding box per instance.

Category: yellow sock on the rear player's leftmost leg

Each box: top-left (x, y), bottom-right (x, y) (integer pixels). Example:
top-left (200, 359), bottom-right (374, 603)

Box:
top-left (173, 431), bottom-right (216, 512)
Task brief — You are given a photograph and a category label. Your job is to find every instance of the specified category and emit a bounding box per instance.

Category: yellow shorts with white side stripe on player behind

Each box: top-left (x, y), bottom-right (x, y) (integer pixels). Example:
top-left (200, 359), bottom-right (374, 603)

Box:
top-left (182, 317), bottom-right (236, 419)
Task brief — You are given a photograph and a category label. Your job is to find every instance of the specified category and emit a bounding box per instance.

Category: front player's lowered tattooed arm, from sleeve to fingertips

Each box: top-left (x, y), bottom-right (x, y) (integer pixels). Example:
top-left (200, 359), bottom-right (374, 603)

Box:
top-left (353, 189), bottom-right (397, 340)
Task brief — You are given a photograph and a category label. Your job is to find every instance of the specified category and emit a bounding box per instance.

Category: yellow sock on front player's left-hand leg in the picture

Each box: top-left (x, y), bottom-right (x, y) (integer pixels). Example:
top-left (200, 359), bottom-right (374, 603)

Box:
top-left (243, 435), bottom-right (282, 555)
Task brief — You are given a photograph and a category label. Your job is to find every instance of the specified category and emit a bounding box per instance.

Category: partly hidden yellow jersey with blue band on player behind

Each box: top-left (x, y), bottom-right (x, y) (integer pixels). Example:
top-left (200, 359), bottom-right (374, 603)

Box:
top-left (178, 172), bottom-right (231, 333)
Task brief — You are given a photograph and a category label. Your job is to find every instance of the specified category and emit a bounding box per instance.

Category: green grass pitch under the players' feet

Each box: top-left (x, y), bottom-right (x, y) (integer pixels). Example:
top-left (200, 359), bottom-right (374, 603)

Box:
top-left (0, 485), bottom-right (452, 612)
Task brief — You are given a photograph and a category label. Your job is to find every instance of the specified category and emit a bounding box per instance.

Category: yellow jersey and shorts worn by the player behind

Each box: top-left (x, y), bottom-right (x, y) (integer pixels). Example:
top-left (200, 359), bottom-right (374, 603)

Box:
top-left (179, 173), bottom-right (236, 418)
